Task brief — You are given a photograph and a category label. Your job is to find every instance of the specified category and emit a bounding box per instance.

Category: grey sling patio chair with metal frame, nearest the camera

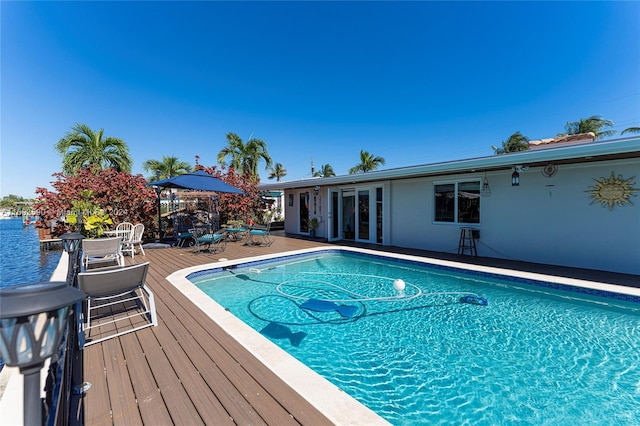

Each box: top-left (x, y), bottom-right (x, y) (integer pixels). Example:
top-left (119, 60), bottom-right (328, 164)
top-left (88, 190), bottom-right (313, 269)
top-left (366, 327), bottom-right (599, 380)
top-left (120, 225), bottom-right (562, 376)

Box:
top-left (78, 262), bottom-right (158, 348)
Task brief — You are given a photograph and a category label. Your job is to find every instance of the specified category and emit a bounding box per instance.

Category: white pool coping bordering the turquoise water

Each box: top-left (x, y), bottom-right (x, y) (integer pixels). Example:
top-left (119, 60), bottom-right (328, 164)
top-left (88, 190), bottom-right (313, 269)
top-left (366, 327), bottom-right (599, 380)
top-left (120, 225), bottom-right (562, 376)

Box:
top-left (167, 245), bottom-right (640, 425)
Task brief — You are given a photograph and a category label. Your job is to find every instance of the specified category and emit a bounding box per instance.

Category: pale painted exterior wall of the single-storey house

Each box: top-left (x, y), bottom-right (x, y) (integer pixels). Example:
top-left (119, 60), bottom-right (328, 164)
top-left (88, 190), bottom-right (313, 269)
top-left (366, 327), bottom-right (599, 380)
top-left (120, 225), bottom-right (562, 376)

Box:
top-left (285, 158), bottom-right (640, 274)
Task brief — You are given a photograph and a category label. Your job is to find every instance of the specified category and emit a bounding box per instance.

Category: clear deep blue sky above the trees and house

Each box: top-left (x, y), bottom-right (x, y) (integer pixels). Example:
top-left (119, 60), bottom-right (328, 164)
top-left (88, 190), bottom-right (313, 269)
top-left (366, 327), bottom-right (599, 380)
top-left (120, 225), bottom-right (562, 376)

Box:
top-left (0, 1), bottom-right (640, 197)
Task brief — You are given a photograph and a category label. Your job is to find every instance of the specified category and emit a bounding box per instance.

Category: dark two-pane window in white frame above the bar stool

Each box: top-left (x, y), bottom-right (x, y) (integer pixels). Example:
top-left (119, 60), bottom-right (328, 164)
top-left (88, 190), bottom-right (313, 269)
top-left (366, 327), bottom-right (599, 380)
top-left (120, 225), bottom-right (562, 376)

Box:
top-left (434, 180), bottom-right (480, 223)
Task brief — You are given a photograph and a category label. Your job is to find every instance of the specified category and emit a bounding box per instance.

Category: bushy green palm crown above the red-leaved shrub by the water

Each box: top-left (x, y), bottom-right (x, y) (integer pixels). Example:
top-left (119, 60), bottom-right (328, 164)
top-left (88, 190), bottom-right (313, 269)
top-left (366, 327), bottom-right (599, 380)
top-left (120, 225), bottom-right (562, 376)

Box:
top-left (55, 123), bottom-right (133, 175)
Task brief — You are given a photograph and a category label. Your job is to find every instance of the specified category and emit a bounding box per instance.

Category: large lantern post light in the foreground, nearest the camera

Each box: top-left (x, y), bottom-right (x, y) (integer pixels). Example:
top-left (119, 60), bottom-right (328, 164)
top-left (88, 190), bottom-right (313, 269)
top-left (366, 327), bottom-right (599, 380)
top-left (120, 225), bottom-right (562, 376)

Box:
top-left (0, 281), bottom-right (85, 425)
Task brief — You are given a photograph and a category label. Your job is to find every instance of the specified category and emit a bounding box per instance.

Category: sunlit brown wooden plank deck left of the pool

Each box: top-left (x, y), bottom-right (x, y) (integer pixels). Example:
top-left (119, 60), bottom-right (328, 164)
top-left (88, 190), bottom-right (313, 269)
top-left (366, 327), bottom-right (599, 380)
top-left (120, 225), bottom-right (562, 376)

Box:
top-left (71, 237), bottom-right (332, 425)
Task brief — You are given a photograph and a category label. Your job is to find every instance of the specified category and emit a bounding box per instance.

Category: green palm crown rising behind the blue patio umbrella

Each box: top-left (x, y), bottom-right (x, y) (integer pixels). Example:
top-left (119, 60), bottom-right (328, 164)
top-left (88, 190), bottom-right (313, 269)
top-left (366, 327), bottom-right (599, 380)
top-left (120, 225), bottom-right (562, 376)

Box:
top-left (218, 132), bottom-right (272, 179)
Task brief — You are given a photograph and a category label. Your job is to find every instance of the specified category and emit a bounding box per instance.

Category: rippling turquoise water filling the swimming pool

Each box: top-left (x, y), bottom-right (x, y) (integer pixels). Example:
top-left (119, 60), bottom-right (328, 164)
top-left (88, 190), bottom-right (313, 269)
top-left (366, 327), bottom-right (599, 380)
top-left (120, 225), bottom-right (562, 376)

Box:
top-left (189, 252), bottom-right (640, 425)
